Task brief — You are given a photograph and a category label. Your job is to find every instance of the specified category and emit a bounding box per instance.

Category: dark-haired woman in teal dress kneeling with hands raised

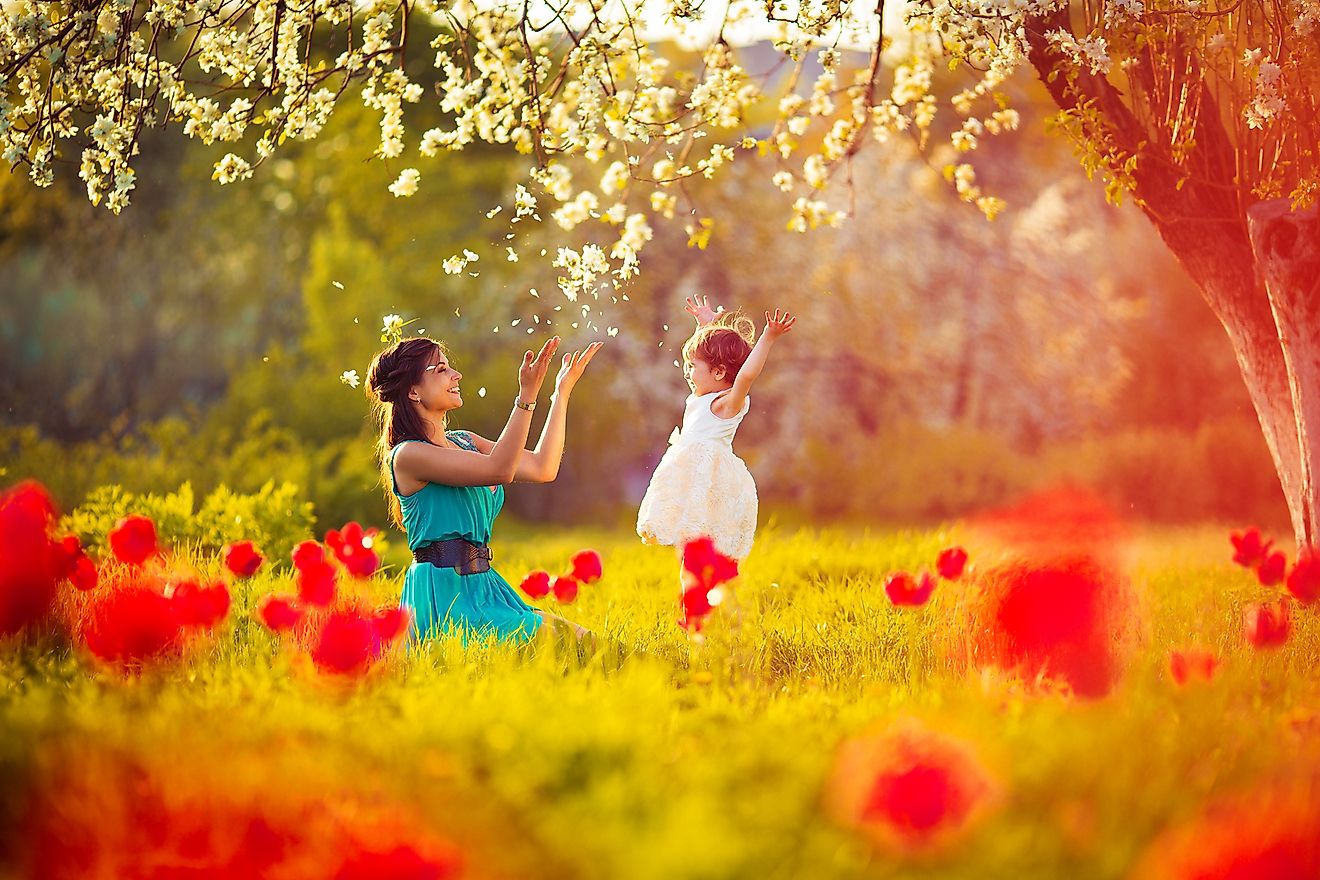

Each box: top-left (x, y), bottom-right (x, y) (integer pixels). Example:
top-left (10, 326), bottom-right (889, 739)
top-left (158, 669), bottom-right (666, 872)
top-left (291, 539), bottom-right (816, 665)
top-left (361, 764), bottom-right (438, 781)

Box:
top-left (367, 336), bottom-right (602, 641)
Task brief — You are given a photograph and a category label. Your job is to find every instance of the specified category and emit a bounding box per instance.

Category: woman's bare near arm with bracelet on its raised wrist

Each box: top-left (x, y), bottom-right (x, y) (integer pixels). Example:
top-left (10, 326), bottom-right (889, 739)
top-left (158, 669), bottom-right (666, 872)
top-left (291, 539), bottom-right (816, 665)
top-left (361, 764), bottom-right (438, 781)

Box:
top-left (395, 336), bottom-right (560, 486)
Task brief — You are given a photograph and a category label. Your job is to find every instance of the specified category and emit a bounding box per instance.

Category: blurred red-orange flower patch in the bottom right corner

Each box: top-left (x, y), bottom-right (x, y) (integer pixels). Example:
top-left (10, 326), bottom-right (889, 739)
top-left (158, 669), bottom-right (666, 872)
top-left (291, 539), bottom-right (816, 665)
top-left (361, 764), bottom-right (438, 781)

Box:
top-left (1131, 778), bottom-right (1320, 880)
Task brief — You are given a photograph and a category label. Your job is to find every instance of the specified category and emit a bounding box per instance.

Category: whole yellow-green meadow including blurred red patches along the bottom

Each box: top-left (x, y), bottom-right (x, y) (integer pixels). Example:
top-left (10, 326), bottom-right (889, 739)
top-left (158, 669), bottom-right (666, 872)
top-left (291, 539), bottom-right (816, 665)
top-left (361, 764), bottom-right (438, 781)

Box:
top-left (0, 506), bottom-right (1320, 880)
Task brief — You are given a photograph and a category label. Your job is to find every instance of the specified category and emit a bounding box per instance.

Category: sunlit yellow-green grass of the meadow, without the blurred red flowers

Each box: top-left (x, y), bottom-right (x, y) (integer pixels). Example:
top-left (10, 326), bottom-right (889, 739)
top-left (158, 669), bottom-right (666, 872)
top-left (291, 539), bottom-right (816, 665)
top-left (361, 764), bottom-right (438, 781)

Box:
top-left (0, 528), bottom-right (1320, 880)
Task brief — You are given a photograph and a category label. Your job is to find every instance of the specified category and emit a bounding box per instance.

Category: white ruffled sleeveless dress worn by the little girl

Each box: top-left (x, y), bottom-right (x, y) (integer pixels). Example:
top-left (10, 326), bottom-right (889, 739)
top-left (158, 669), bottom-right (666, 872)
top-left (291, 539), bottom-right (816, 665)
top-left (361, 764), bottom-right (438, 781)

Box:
top-left (638, 391), bottom-right (756, 559)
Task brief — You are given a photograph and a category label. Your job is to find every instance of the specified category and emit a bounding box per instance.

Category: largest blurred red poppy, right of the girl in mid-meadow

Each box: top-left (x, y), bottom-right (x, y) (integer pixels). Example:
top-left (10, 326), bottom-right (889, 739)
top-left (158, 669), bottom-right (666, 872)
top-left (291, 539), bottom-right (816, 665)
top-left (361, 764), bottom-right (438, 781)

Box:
top-left (969, 555), bottom-right (1135, 697)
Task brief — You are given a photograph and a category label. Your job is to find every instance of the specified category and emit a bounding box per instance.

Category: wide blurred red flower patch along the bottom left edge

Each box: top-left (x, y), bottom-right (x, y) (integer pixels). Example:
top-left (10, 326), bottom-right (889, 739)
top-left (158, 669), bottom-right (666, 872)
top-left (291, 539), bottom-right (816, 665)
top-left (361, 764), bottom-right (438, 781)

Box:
top-left (13, 745), bottom-right (465, 880)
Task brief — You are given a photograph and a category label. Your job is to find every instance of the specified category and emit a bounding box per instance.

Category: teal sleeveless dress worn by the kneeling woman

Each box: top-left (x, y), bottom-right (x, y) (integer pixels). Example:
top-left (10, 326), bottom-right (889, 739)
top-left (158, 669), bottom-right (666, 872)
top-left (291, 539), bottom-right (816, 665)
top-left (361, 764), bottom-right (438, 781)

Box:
top-left (389, 431), bottom-right (541, 641)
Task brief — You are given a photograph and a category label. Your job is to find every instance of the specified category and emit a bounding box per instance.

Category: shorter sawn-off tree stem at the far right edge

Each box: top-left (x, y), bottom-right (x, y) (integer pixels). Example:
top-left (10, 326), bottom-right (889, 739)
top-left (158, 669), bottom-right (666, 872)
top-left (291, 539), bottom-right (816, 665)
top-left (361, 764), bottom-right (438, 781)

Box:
top-left (1247, 199), bottom-right (1320, 548)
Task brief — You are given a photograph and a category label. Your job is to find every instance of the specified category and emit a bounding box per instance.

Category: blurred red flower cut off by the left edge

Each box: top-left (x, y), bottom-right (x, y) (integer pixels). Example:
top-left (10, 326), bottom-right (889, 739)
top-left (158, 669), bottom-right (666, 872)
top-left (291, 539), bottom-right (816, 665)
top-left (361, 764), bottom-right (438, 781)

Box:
top-left (0, 480), bottom-right (69, 636)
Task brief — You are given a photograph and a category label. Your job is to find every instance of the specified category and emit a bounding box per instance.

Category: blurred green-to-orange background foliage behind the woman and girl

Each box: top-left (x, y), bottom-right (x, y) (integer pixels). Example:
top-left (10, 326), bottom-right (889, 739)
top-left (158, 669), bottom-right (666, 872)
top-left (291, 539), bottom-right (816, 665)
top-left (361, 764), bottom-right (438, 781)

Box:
top-left (0, 68), bottom-right (1276, 522)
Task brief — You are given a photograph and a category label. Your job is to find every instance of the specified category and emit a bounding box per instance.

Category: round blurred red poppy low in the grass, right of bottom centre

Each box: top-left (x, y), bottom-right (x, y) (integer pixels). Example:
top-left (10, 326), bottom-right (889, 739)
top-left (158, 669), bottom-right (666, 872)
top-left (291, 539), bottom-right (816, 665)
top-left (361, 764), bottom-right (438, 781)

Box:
top-left (825, 720), bottom-right (997, 851)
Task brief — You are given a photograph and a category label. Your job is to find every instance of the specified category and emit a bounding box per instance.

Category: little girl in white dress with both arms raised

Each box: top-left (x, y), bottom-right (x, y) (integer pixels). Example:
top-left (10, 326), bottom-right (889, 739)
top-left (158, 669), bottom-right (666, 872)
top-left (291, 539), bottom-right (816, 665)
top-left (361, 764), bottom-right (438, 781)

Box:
top-left (638, 297), bottom-right (797, 559)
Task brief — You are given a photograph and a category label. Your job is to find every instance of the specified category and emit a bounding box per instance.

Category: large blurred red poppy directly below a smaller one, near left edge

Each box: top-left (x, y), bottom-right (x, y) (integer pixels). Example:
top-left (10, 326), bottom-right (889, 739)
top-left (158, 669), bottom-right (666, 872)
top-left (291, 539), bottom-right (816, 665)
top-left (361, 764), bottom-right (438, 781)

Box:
top-left (83, 583), bottom-right (183, 666)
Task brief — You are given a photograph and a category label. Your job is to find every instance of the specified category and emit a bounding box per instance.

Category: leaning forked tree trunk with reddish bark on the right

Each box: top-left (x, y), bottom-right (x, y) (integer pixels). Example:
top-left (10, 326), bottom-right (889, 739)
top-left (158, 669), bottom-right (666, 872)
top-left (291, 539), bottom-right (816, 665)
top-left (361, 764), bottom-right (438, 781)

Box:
top-left (1028, 11), bottom-right (1304, 546)
